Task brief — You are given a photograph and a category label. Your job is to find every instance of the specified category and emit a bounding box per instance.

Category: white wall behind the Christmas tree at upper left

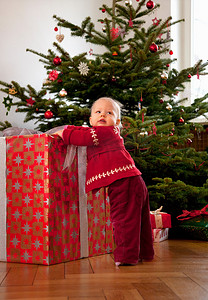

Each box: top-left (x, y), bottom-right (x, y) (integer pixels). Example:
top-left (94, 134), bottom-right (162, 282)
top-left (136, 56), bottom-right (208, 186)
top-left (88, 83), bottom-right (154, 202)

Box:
top-left (0, 0), bottom-right (170, 129)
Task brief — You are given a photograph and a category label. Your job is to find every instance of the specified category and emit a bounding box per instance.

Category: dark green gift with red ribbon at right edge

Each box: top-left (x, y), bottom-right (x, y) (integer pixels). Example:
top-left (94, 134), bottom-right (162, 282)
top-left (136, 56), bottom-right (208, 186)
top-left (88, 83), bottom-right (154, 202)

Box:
top-left (177, 204), bottom-right (208, 241)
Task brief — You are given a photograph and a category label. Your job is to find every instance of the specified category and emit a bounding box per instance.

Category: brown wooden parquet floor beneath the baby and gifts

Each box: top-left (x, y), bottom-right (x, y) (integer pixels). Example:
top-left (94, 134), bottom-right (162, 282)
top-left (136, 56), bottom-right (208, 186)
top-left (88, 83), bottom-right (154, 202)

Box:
top-left (0, 240), bottom-right (208, 300)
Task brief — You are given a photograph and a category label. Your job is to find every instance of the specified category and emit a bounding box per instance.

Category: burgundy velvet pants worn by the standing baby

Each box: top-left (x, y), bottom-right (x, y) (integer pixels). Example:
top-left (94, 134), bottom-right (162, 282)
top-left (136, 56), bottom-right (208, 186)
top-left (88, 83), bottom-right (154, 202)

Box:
top-left (108, 176), bottom-right (154, 264)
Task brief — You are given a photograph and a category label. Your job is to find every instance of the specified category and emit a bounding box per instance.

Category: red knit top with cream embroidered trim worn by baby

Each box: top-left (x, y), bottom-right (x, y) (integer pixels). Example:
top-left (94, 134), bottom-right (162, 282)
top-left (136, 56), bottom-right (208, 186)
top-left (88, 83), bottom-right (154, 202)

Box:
top-left (63, 125), bottom-right (141, 192)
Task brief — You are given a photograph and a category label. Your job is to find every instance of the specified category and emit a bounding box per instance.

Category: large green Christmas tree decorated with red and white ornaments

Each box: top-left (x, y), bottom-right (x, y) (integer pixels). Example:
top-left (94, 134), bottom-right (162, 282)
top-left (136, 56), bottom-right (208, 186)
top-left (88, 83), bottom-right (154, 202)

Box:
top-left (0, 0), bottom-right (208, 225)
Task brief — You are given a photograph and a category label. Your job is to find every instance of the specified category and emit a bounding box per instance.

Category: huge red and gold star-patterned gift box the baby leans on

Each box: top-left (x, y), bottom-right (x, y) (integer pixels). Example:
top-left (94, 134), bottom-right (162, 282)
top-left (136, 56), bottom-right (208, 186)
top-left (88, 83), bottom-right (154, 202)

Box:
top-left (0, 134), bottom-right (113, 265)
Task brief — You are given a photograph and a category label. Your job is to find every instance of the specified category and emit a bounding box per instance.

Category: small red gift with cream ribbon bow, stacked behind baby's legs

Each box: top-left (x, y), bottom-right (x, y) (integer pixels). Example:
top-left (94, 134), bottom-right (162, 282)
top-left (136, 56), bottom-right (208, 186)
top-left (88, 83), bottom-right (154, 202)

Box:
top-left (150, 206), bottom-right (171, 229)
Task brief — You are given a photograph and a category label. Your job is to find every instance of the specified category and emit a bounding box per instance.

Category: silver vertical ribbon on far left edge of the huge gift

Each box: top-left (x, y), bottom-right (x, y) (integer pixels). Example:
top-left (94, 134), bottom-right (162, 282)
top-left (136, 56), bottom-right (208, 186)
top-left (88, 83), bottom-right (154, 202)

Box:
top-left (0, 137), bottom-right (7, 261)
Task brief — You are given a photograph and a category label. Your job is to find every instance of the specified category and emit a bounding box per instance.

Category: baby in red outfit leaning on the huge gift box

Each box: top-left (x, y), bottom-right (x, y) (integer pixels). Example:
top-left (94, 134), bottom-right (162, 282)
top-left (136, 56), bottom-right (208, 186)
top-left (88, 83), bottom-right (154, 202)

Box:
top-left (56, 97), bottom-right (154, 266)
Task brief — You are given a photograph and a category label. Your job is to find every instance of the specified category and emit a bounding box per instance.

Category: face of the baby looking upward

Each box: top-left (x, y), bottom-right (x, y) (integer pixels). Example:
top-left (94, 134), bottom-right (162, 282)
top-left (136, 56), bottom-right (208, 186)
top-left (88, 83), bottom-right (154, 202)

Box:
top-left (90, 99), bottom-right (120, 126)
